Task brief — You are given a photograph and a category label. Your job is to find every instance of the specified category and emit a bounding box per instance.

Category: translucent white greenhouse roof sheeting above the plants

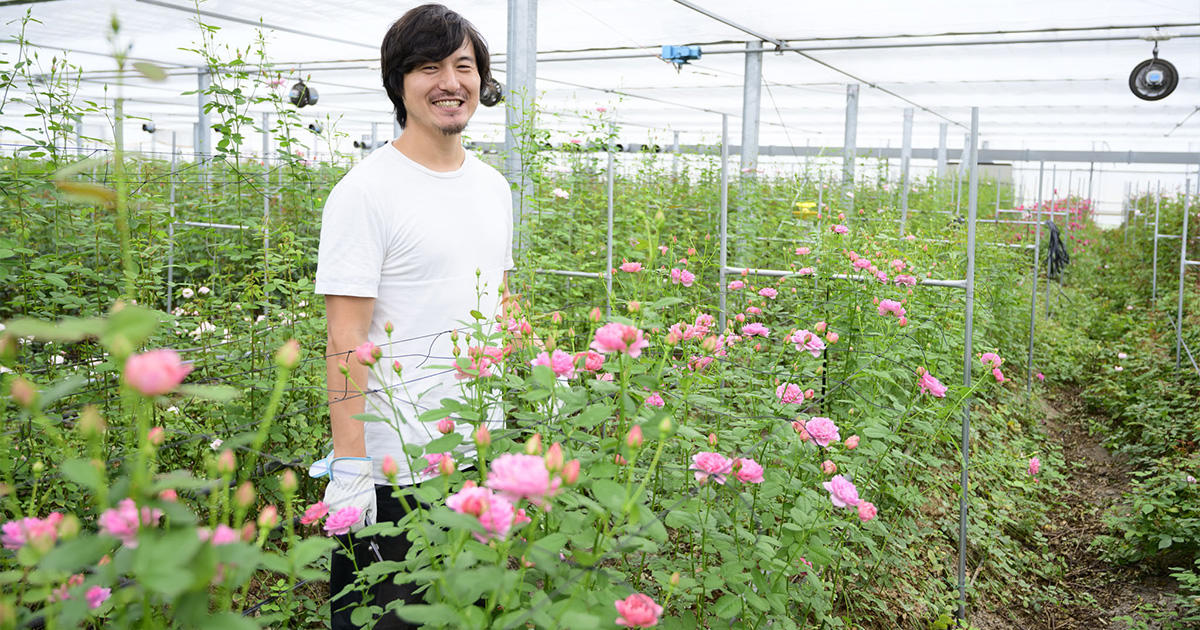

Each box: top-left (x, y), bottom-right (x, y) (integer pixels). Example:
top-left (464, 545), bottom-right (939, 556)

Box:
top-left (0, 0), bottom-right (1200, 219)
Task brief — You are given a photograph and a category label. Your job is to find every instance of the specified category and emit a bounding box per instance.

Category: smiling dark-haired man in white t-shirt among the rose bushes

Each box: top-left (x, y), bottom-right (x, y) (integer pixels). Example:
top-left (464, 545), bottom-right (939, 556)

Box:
top-left (314, 5), bottom-right (512, 630)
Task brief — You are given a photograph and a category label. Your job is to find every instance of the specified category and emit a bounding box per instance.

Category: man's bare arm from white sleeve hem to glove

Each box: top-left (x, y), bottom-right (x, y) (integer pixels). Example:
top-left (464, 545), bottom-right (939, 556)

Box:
top-left (325, 295), bottom-right (374, 457)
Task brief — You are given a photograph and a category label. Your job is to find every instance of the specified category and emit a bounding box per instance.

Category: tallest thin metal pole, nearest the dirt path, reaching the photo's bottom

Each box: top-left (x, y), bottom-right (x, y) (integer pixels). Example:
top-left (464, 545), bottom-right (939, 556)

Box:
top-left (959, 107), bottom-right (979, 622)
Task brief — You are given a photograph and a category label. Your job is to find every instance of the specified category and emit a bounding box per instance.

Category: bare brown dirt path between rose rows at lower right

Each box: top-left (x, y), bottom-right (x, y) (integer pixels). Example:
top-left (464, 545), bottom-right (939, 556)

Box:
top-left (974, 396), bottom-right (1176, 630)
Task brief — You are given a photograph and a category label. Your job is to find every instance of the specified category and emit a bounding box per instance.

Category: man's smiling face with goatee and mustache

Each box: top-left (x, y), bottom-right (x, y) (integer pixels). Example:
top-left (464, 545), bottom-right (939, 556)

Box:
top-left (404, 40), bottom-right (479, 136)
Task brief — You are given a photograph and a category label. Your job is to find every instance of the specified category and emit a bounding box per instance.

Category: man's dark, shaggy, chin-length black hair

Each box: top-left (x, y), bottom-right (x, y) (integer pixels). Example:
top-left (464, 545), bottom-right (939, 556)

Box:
top-left (379, 4), bottom-right (494, 127)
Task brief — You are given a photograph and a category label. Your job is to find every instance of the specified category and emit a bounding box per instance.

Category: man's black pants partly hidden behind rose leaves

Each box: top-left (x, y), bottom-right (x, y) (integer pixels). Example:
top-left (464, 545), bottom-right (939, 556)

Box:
top-left (329, 486), bottom-right (424, 630)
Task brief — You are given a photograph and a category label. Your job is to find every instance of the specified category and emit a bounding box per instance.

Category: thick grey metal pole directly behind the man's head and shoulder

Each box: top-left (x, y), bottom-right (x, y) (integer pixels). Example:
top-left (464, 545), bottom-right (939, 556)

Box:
top-left (504, 0), bottom-right (538, 254)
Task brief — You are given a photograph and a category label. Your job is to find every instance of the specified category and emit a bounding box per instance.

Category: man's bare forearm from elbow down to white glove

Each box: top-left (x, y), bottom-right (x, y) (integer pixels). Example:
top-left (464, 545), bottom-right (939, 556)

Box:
top-left (325, 338), bottom-right (367, 457)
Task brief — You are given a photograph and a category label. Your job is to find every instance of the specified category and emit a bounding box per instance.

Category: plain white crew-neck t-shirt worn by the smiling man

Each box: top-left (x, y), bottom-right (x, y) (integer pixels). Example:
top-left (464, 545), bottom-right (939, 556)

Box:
top-left (316, 143), bottom-right (512, 485)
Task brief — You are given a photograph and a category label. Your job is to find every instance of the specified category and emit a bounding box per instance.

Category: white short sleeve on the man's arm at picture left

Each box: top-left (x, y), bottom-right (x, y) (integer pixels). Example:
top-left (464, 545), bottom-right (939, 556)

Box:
top-left (316, 179), bottom-right (386, 298)
